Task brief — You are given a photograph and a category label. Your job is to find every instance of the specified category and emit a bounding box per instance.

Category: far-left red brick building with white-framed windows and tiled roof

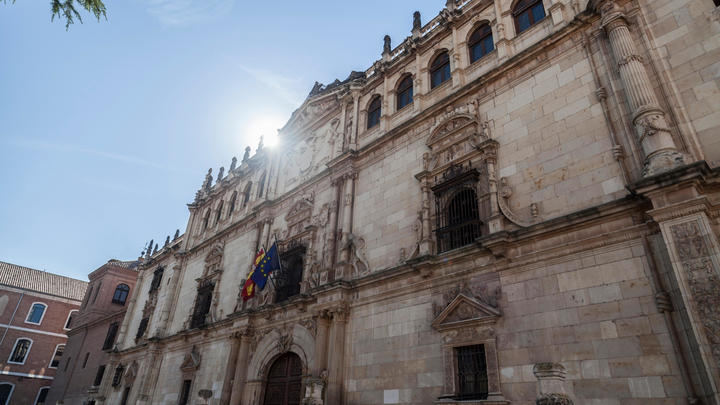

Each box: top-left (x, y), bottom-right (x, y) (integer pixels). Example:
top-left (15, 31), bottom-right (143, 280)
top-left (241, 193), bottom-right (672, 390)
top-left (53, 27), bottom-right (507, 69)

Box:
top-left (0, 262), bottom-right (87, 405)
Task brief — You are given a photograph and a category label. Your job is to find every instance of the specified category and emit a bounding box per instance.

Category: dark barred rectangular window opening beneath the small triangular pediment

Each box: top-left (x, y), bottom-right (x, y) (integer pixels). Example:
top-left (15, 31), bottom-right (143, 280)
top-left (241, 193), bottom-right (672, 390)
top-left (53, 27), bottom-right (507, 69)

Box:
top-left (455, 345), bottom-right (488, 400)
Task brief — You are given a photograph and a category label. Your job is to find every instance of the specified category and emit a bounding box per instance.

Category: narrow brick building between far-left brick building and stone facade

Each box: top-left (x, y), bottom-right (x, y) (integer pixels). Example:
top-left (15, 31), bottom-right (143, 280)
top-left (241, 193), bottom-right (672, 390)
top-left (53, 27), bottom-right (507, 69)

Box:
top-left (46, 260), bottom-right (140, 405)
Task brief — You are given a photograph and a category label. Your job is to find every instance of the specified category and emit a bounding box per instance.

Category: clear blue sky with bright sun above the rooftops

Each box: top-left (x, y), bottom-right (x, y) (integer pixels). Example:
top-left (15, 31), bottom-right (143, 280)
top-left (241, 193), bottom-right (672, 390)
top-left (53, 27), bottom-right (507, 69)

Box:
top-left (0, 0), bottom-right (445, 279)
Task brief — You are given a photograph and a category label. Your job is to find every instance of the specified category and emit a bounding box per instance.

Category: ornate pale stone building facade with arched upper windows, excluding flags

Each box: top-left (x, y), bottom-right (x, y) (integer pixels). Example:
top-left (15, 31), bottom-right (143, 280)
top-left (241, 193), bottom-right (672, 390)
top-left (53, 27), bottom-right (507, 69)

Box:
top-left (97, 0), bottom-right (720, 405)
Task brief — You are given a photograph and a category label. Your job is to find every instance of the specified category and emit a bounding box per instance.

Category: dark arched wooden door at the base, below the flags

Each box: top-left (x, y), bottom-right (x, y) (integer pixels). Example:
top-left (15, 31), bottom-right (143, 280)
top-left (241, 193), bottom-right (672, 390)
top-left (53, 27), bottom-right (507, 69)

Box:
top-left (264, 353), bottom-right (302, 405)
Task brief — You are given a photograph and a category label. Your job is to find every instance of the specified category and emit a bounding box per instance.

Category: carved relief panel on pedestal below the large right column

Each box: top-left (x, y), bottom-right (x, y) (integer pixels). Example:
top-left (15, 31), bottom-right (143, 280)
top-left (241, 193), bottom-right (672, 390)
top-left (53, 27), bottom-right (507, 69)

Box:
top-left (670, 220), bottom-right (720, 362)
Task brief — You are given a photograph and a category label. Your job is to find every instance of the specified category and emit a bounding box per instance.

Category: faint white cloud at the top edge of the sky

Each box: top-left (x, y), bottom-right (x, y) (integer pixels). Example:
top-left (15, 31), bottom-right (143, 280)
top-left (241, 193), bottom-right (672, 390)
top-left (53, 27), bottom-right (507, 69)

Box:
top-left (146, 0), bottom-right (235, 26)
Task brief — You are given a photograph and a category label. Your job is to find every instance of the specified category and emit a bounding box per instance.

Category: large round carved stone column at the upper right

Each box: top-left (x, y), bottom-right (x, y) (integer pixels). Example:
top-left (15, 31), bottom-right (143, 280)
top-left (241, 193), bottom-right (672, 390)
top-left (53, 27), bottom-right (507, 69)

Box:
top-left (597, 0), bottom-right (685, 176)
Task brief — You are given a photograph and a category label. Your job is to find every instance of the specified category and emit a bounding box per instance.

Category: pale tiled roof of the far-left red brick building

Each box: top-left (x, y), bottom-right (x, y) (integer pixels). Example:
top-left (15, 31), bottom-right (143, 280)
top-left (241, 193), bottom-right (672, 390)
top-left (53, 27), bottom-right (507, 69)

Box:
top-left (0, 261), bottom-right (88, 301)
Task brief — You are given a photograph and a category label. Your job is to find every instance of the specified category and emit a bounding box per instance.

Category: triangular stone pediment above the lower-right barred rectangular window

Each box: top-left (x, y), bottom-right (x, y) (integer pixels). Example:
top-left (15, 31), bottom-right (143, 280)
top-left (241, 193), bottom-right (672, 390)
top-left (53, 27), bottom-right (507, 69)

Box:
top-left (432, 293), bottom-right (500, 330)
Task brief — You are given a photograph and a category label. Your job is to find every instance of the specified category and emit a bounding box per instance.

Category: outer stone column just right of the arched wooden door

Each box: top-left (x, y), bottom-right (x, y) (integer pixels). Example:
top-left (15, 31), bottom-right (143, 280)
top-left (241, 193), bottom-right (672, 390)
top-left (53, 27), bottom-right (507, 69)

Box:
top-left (325, 306), bottom-right (349, 404)
